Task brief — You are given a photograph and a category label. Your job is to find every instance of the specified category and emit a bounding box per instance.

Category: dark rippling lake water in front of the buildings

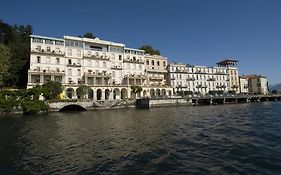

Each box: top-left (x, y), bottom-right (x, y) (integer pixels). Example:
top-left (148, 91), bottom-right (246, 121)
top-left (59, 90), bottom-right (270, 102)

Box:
top-left (0, 102), bottom-right (281, 175)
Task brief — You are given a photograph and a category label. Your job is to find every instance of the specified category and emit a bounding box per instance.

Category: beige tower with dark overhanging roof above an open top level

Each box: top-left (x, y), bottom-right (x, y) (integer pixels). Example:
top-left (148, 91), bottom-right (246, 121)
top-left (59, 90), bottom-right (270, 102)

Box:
top-left (217, 59), bottom-right (237, 93)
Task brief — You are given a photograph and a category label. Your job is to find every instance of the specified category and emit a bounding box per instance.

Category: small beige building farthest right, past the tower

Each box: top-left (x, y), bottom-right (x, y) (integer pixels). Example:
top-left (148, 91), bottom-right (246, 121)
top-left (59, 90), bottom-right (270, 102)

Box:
top-left (245, 75), bottom-right (269, 95)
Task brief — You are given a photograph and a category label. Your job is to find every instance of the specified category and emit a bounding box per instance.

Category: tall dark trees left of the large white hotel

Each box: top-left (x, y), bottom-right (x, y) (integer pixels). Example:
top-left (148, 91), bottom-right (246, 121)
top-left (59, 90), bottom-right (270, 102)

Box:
top-left (0, 20), bottom-right (32, 88)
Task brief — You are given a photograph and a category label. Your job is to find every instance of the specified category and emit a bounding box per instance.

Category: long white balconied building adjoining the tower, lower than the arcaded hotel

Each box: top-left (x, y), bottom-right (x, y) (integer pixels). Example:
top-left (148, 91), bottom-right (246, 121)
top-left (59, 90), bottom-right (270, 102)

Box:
top-left (168, 63), bottom-right (229, 95)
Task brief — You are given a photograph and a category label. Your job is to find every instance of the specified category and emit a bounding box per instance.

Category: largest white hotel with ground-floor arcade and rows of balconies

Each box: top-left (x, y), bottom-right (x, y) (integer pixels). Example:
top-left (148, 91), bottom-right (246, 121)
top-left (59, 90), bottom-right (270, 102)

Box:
top-left (27, 35), bottom-right (172, 100)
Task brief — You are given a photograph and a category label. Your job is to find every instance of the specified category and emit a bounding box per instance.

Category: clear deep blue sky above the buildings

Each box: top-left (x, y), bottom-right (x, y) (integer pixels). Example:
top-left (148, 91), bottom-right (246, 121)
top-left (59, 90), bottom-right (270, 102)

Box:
top-left (0, 0), bottom-right (281, 84)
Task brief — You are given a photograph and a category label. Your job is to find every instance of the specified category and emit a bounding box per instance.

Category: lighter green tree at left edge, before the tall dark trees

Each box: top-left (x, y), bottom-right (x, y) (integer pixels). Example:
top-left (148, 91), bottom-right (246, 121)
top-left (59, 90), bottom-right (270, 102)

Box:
top-left (0, 44), bottom-right (11, 88)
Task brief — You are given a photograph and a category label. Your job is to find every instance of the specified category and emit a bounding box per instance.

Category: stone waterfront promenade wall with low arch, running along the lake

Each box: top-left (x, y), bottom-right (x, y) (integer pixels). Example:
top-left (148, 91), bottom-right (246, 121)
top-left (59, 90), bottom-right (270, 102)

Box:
top-left (48, 95), bottom-right (281, 111)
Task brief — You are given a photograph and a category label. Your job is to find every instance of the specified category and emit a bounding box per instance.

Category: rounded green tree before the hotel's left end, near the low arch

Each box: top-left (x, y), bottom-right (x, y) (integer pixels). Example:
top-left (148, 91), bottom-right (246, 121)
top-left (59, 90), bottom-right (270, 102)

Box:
top-left (42, 81), bottom-right (62, 100)
